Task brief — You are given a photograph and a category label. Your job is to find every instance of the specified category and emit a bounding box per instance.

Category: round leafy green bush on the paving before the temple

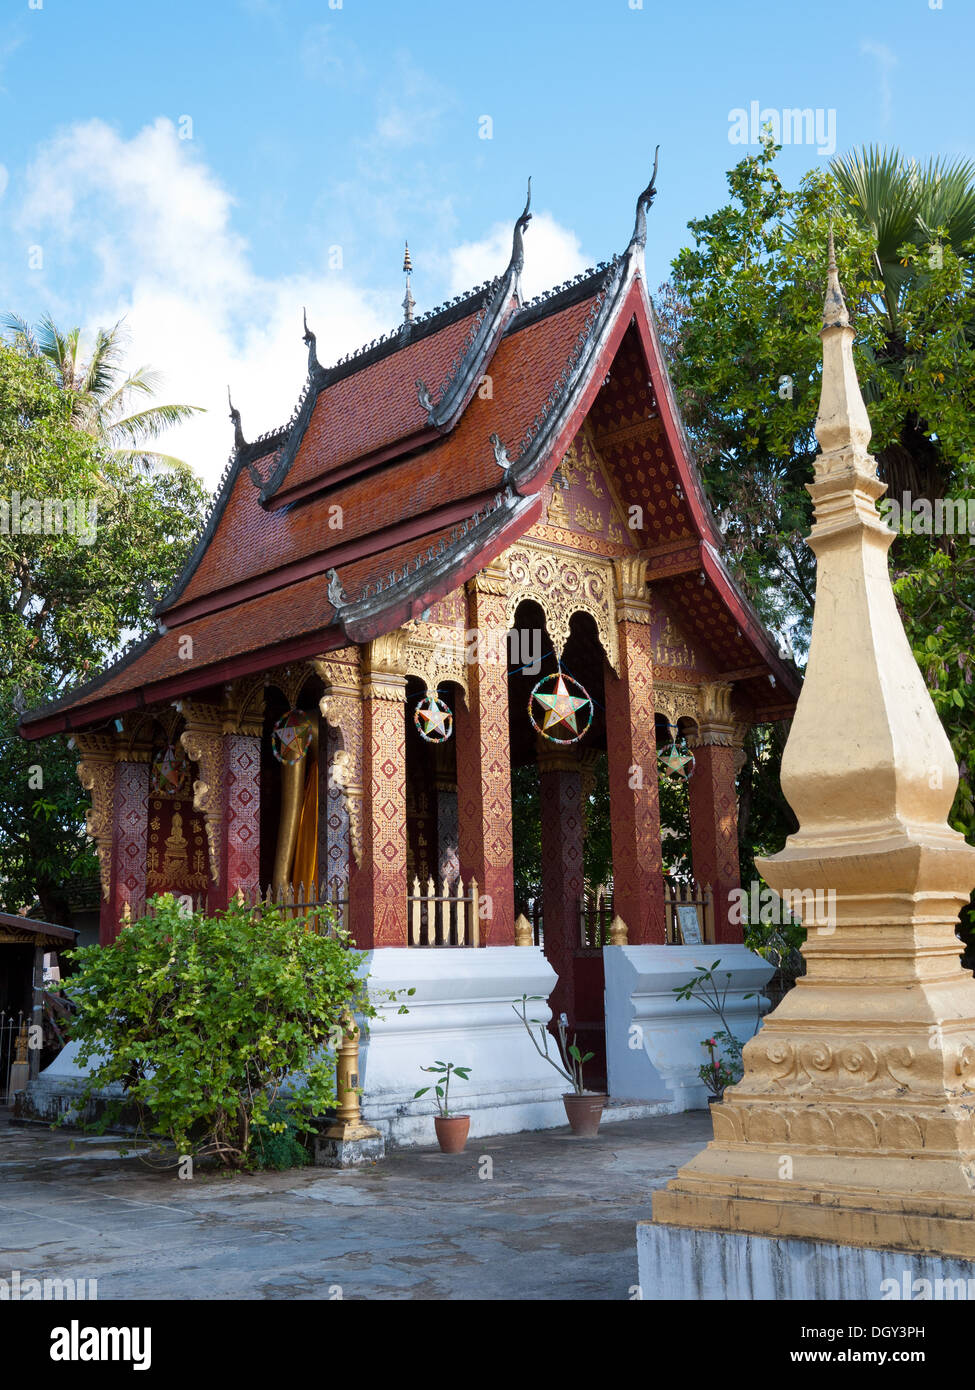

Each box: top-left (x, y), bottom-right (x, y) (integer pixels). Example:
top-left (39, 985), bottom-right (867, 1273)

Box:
top-left (60, 894), bottom-right (376, 1168)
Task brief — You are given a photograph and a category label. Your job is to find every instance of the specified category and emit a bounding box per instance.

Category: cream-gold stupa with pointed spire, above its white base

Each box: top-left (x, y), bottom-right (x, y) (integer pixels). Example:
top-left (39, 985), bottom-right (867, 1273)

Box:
top-left (654, 236), bottom-right (975, 1258)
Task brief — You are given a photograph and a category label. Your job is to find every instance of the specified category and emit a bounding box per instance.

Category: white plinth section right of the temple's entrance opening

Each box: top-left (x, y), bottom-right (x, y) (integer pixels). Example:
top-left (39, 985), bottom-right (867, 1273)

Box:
top-left (602, 944), bottom-right (772, 1111)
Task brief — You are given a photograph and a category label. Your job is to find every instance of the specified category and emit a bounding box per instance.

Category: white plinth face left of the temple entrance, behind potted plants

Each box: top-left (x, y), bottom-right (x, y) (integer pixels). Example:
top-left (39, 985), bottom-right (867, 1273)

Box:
top-left (359, 947), bottom-right (569, 1145)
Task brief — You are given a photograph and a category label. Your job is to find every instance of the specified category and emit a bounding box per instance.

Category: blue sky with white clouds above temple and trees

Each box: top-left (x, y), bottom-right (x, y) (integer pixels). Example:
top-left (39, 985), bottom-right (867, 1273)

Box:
top-left (0, 0), bottom-right (975, 482)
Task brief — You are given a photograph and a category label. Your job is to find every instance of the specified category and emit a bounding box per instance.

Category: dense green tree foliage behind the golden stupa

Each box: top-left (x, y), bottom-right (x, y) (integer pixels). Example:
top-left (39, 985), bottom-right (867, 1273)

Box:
top-left (656, 138), bottom-right (975, 934)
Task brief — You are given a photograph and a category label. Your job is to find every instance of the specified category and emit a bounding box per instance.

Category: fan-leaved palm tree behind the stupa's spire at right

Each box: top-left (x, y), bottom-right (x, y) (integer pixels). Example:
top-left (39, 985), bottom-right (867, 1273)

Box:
top-left (832, 146), bottom-right (975, 499)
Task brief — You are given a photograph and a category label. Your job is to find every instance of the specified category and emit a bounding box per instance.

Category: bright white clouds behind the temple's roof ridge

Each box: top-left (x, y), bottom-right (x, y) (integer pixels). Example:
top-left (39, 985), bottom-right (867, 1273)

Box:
top-left (17, 120), bottom-right (584, 487)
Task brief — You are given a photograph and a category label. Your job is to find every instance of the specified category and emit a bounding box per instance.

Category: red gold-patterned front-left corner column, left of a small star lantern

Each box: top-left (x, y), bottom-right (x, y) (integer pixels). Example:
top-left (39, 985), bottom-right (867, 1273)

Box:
top-left (349, 656), bottom-right (409, 951)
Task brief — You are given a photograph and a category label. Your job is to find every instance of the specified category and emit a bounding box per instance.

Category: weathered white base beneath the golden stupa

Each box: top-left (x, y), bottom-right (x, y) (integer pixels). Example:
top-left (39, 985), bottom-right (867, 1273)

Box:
top-left (637, 1222), bottom-right (975, 1302)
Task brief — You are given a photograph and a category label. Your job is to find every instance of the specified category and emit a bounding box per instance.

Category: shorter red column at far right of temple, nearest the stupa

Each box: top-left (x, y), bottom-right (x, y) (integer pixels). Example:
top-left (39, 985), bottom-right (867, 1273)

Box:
top-left (688, 706), bottom-right (743, 941)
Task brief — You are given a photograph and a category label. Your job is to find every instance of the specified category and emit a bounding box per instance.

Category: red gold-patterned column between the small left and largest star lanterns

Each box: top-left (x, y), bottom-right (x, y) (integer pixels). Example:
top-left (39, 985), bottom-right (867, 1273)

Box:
top-left (455, 563), bottom-right (515, 947)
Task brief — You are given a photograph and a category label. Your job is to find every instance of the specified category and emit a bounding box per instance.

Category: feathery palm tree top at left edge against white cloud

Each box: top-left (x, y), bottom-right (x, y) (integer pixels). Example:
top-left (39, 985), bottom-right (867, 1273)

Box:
top-left (4, 314), bottom-right (202, 468)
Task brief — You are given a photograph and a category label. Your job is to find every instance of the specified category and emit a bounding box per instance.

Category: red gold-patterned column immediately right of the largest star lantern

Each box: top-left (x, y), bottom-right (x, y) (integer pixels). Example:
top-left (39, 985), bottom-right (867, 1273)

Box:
top-left (605, 562), bottom-right (665, 945)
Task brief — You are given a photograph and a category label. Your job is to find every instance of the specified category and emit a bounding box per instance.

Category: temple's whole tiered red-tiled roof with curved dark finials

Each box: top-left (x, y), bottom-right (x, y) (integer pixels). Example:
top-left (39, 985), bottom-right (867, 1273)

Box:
top-left (22, 164), bottom-right (797, 738)
